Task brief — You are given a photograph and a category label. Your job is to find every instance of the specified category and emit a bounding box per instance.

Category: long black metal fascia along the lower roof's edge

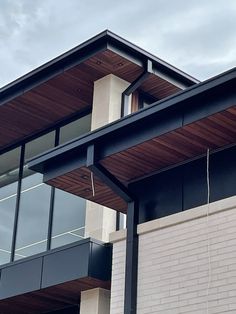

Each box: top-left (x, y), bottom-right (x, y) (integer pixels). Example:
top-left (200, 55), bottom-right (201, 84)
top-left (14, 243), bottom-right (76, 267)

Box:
top-left (29, 68), bottom-right (236, 172)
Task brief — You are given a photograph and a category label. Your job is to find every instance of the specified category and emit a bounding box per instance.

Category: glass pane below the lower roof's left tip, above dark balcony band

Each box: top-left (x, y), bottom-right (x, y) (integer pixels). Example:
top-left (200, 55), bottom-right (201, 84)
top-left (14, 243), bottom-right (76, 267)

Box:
top-left (15, 173), bottom-right (51, 259)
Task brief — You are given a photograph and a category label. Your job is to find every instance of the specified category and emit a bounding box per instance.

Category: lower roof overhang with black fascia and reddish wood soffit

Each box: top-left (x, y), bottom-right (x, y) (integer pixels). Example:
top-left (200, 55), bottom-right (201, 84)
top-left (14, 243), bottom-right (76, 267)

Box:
top-left (29, 68), bottom-right (236, 212)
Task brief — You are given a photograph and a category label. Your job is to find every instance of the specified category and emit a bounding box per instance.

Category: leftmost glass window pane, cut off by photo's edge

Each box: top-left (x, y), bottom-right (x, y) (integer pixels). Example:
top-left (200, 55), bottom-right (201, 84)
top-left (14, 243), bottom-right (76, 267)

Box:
top-left (0, 148), bottom-right (20, 264)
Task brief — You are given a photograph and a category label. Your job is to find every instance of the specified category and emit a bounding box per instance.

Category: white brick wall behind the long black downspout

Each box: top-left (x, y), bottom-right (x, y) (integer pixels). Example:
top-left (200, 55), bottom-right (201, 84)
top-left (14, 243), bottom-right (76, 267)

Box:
top-left (111, 197), bottom-right (236, 314)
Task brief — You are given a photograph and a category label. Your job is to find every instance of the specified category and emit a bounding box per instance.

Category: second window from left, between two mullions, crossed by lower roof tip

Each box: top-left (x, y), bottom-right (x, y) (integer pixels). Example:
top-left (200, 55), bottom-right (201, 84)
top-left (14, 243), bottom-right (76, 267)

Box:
top-left (15, 132), bottom-right (55, 259)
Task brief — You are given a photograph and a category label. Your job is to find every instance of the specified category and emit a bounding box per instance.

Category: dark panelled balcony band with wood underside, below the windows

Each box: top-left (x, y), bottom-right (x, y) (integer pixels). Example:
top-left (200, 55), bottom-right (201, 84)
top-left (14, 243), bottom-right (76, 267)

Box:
top-left (0, 239), bottom-right (111, 314)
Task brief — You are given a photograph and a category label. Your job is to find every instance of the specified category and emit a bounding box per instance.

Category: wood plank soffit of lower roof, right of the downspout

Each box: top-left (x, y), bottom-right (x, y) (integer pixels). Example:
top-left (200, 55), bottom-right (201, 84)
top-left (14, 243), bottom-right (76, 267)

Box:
top-left (101, 108), bottom-right (236, 184)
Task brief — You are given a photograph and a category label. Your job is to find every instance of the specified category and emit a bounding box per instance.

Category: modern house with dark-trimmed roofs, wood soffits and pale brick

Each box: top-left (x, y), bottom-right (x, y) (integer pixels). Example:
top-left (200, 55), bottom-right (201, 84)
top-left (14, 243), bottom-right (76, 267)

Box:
top-left (0, 31), bottom-right (236, 314)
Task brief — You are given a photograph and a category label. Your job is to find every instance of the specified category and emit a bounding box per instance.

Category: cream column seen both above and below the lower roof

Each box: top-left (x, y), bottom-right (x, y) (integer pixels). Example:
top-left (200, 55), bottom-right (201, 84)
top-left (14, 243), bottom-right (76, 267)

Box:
top-left (85, 74), bottom-right (129, 242)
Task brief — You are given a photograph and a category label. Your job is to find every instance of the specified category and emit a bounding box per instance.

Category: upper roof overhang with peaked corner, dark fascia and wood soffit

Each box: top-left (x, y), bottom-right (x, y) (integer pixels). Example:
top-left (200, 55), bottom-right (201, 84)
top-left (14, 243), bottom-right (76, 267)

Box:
top-left (0, 31), bottom-right (198, 151)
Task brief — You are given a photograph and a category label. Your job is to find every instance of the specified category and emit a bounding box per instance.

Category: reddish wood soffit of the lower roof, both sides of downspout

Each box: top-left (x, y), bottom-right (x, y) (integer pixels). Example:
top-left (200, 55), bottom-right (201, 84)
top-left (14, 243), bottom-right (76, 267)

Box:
top-left (47, 106), bottom-right (236, 212)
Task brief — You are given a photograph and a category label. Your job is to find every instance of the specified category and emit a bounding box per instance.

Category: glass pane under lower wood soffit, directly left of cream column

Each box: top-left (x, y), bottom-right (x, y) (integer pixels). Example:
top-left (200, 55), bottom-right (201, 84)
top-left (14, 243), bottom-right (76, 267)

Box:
top-left (51, 189), bottom-right (86, 248)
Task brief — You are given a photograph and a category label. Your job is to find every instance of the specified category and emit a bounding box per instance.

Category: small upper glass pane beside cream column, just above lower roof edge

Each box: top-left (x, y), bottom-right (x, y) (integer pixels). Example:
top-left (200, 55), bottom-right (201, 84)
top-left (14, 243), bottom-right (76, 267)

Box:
top-left (59, 114), bottom-right (91, 144)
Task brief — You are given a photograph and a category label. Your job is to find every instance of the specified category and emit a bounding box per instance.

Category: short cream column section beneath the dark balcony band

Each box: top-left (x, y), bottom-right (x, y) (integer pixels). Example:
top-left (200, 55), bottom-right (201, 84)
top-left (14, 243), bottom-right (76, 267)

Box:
top-left (80, 288), bottom-right (110, 314)
